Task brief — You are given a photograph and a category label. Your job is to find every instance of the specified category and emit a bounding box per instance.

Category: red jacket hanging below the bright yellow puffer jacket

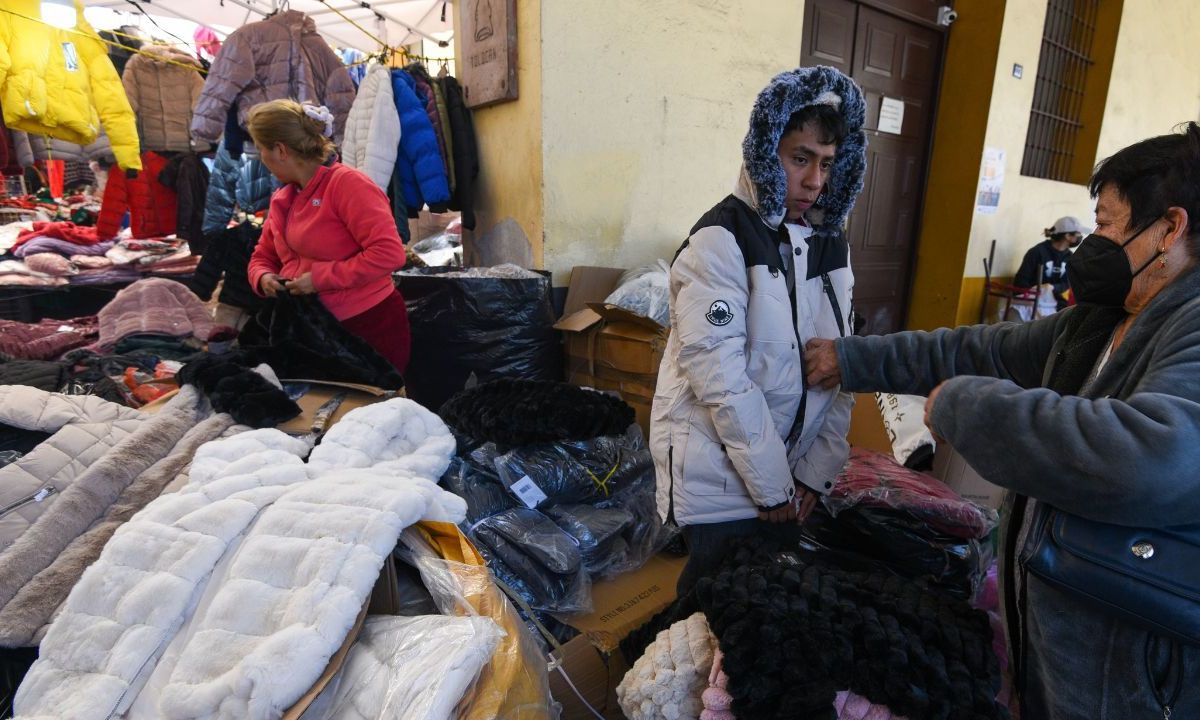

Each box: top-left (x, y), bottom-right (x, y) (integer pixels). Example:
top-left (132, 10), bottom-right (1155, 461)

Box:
top-left (96, 151), bottom-right (178, 240)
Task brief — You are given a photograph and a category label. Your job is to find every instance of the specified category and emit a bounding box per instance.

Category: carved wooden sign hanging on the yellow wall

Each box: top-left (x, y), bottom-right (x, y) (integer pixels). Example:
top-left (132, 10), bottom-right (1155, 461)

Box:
top-left (455, 0), bottom-right (517, 108)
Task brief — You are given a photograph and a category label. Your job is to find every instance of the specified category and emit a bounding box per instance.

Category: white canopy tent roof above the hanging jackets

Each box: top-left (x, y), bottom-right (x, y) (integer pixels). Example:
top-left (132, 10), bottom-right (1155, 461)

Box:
top-left (85, 0), bottom-right (454, 56)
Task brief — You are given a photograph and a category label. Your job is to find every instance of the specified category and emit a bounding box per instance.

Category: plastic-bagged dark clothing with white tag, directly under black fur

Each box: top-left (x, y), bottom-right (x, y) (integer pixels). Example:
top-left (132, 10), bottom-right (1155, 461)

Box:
top-left (472, 425), bottom-right (654, 508)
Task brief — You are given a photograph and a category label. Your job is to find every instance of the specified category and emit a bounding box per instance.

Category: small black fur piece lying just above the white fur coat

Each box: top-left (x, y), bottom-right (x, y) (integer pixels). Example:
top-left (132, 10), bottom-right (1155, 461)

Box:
top-left (176, 353), bottom-right (301, 427)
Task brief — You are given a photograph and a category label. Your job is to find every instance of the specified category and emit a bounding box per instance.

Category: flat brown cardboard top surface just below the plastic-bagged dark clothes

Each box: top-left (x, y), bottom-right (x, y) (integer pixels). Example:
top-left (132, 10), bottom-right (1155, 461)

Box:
top-left (558, 554), bottom-right (688, 653)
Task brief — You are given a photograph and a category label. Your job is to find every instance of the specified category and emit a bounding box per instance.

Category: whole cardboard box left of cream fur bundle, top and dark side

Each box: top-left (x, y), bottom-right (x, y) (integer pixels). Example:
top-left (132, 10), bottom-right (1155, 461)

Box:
top-left (550, 554), bottom-right (688, 720)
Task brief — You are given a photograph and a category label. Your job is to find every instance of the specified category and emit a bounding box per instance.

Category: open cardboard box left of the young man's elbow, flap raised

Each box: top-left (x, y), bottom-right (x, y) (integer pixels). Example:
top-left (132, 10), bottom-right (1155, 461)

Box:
top-left (554, 265), bottom-right (670, 437)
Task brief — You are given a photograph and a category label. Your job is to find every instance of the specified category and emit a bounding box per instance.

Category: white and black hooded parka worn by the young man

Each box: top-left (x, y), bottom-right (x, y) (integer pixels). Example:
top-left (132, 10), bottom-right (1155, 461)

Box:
top-left (650, 67), bottom-right (866, 526)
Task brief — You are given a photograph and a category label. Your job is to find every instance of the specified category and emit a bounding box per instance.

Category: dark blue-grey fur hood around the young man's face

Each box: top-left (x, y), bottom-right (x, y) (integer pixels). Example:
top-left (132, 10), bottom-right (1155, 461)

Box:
top-left (734, 66), bottom-right (866, 229)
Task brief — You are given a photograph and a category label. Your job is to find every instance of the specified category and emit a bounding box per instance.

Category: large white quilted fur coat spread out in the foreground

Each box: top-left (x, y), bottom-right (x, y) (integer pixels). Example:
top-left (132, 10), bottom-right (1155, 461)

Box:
top-left (16, 400), bottom-right (466, 719)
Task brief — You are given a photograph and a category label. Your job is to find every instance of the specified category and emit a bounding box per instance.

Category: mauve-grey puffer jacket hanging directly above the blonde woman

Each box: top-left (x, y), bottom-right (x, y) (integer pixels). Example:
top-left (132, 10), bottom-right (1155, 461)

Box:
top-left (192, 10), bottom-right (354, 143)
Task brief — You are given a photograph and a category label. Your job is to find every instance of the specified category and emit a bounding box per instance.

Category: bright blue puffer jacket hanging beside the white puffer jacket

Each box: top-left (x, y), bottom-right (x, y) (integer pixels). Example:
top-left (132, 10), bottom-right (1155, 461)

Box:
top-left (391, 70), bottom-right (450, 212)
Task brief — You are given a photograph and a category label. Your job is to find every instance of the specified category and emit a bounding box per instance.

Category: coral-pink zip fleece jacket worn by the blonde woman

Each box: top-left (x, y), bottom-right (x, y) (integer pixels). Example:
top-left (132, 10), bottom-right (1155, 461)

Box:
top-left (247, 162), bottom-right (404, 320)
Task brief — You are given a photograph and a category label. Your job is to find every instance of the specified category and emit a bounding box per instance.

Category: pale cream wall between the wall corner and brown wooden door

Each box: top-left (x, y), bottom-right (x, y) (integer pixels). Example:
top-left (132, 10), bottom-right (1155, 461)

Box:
top-left (541, 0), bottom-right (804, 284)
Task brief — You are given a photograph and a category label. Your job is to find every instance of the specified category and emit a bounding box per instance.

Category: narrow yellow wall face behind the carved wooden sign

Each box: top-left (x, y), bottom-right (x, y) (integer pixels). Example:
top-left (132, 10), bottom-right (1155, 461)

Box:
top-left (455, 0), bottom-right (542, 266)
